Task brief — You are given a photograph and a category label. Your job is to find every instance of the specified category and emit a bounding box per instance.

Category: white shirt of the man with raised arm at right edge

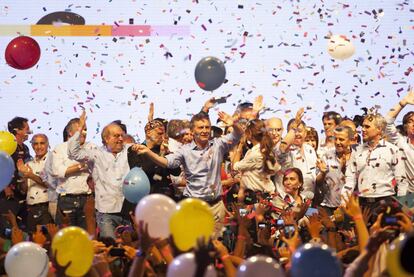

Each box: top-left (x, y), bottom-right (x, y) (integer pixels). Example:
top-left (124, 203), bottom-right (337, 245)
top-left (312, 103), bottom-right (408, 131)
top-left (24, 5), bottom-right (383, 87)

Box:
top-left (385, 116), bottom-right (414, 192)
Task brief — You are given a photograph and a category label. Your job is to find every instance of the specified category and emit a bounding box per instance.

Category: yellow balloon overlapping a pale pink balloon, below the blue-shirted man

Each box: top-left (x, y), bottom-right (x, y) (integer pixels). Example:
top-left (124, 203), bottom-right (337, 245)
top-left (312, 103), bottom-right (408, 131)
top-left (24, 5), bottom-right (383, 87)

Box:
top-left (170, 198), bottom-right (214, 251)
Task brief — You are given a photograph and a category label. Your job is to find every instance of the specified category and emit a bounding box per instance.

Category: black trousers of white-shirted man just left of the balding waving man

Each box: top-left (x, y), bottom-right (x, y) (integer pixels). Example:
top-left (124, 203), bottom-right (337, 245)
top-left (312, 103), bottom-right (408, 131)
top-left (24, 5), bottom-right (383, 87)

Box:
top-left (56, 194), bottom-right (88, 229)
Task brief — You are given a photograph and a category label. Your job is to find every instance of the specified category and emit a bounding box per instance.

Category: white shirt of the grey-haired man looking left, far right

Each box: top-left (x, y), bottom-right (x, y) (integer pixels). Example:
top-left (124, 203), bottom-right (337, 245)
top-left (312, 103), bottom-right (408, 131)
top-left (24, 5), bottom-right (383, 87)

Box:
top-left (342, 140), bottom-right (408, 198)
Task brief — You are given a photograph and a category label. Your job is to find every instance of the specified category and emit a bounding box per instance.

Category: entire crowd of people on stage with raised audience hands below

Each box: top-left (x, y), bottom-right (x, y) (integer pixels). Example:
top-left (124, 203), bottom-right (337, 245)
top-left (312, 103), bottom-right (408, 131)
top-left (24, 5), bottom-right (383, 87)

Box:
top-left (0, 91), bottom-right (414, 277)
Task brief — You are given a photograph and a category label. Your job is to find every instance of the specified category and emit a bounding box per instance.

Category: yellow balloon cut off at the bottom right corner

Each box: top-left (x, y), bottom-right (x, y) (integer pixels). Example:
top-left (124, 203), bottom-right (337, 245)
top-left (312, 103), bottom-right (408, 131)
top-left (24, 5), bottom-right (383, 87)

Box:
top-left (387, 234), bottom-right (414, 277)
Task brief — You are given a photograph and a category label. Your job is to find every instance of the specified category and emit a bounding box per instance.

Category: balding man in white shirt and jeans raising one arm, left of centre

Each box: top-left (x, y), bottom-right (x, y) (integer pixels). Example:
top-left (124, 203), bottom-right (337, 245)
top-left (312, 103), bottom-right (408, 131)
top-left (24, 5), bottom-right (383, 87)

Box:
top-left (68, 112), bottom-right (133, 237)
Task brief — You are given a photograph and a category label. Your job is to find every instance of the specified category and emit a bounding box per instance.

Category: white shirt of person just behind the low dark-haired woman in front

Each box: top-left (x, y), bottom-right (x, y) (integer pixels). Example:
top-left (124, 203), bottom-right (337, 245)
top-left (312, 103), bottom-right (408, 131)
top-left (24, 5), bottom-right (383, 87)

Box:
top-left (279, 143), bottom-right (318, 193)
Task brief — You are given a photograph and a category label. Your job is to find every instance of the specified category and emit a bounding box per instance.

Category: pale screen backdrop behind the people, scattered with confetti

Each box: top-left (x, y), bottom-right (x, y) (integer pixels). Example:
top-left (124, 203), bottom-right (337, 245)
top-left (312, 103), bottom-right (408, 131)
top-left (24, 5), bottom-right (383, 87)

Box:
top-left (0, 0), bottom-right (414, 149)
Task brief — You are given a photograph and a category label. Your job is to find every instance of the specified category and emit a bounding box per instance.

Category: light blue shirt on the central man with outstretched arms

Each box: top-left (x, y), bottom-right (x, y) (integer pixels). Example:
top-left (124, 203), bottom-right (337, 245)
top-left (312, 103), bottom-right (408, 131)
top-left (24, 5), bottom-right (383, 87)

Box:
top-left (165, 132), bottom-right (241, 201)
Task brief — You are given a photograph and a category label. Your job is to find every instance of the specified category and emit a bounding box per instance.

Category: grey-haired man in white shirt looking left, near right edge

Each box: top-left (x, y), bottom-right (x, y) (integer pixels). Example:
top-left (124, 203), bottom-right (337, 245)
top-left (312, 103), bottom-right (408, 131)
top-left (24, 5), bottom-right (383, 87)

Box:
top-left (342, 114), bottom-right (408, 208)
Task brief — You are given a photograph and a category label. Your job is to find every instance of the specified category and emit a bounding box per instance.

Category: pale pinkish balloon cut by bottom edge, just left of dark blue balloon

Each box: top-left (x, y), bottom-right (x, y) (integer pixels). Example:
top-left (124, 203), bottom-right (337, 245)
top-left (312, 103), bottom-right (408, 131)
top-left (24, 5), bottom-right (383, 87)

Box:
top-left (237, 255), bottom-right (285, 277)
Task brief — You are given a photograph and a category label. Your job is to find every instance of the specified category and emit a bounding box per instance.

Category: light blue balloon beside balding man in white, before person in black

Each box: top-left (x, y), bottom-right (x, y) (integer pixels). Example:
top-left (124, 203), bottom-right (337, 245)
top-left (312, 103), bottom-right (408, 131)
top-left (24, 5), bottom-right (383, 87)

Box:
top-left (122, 167), bottom-right (150, 203)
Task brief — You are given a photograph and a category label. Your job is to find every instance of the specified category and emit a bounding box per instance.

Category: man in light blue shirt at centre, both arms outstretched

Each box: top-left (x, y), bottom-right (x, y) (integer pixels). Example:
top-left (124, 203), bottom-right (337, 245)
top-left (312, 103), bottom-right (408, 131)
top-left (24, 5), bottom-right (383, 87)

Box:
top-left (133, 112), bottom-right (243, 236)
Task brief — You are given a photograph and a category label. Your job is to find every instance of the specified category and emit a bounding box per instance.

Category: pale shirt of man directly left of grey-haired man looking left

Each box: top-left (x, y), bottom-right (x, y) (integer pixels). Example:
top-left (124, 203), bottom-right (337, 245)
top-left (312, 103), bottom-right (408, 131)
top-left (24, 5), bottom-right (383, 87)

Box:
top-left (321, 148), bottom-right (345, 208)
